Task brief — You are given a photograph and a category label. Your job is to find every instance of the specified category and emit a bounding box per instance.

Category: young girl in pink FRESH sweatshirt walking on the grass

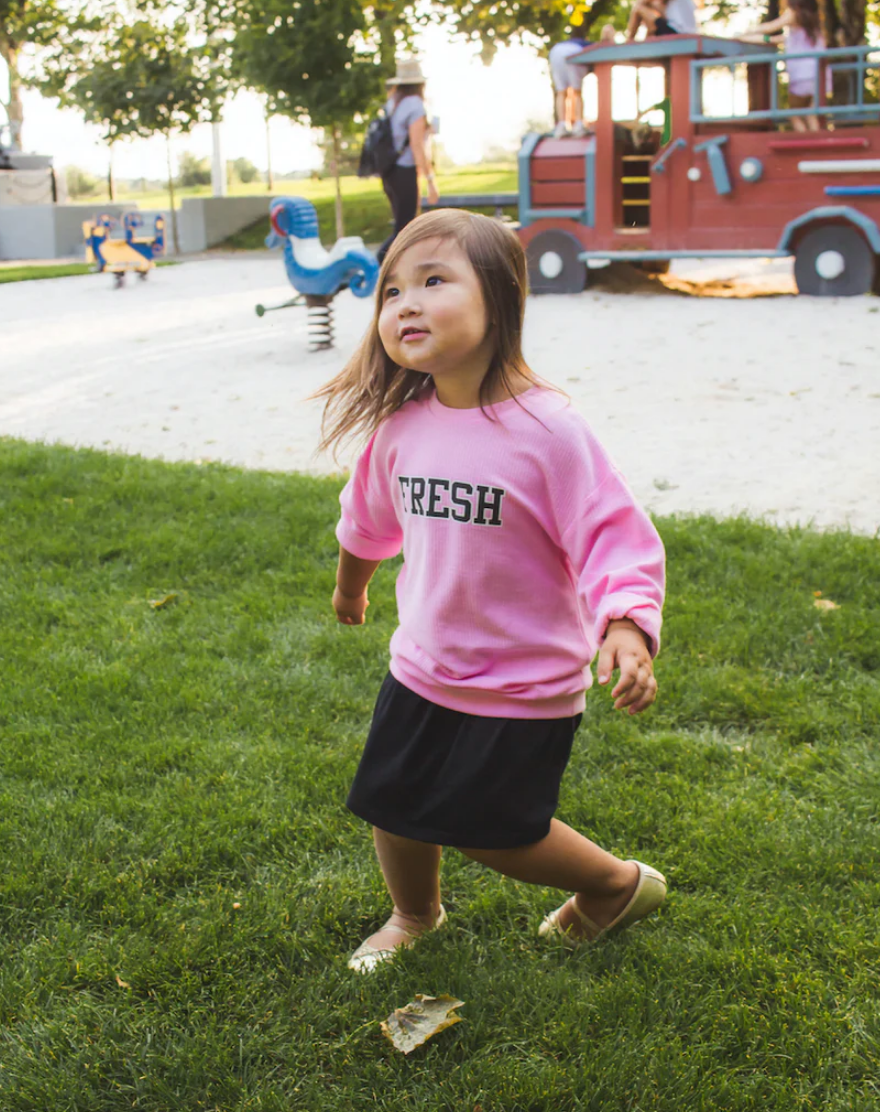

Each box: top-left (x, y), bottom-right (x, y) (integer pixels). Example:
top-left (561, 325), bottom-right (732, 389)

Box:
top-left (318, 210), bottom-right (666, 972)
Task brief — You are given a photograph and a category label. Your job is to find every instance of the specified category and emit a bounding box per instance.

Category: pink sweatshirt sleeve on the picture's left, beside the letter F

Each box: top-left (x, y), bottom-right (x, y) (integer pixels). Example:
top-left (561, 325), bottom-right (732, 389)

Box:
top-left (336, 429), bottom-right (404, 559)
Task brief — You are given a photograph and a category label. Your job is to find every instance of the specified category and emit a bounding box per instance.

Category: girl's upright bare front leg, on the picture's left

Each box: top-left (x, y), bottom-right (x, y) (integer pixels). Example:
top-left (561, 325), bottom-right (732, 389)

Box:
top-left (358, 826), bottom-right (443, 950)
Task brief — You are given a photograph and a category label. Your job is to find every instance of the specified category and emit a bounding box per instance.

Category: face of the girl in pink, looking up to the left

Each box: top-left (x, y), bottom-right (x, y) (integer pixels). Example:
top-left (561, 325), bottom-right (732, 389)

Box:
top-left (378, 238), bottom-right (494, 400)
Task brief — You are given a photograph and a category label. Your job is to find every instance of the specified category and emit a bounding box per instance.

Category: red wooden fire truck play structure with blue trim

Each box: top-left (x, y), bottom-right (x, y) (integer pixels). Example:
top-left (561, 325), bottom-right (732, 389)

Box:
top-left (520, 34), bottom-right (880, 296)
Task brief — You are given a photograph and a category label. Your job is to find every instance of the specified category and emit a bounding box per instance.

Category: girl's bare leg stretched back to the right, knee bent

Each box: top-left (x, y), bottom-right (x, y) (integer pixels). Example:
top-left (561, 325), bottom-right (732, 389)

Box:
top-left (462, 818), bottom-right (639, 936)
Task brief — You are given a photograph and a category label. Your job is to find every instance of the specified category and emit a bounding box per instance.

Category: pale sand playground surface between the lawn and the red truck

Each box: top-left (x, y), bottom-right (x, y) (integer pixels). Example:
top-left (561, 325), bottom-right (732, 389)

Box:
top-left (0, 252), bottom-right (880, 535)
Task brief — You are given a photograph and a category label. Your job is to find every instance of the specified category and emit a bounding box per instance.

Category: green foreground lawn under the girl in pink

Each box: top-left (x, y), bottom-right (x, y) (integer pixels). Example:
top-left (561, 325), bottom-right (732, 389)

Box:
top-left (0, 439), bottom-right (880, 1112)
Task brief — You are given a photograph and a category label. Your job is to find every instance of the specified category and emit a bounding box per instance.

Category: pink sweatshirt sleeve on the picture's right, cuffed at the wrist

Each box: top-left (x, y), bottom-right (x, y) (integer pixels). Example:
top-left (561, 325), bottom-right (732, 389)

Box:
top-left (556, 424), bottom-right (665, 656)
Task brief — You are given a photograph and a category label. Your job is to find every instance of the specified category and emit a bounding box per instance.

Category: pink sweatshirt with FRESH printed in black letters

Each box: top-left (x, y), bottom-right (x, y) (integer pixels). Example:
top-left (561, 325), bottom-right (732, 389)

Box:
top-left (336, 387), bottom-right (664, 718)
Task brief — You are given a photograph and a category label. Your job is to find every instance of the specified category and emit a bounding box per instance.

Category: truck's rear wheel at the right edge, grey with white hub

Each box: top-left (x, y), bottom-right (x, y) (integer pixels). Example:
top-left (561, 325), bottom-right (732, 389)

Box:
top-left (794, 224), bottom-right (877, 297)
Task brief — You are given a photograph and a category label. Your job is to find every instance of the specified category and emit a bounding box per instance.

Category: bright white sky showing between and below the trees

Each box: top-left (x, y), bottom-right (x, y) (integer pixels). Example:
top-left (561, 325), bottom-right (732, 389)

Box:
top-left (0, 8), bottom-right (765, 178)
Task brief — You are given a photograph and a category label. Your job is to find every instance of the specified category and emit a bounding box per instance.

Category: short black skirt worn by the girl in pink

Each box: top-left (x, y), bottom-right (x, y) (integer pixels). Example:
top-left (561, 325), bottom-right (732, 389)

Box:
top-left (347, 674), bottom-right (581, 850)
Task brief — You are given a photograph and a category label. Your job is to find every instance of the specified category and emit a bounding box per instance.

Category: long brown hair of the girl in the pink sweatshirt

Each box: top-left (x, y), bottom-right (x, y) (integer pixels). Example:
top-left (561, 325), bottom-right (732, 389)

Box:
top-left (313, 209), bottom-right (540, 454)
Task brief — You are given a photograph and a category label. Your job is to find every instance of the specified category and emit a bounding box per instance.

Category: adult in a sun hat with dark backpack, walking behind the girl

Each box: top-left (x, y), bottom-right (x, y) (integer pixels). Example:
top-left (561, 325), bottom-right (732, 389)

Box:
top-left (378, 58), bottom-right (439, 262)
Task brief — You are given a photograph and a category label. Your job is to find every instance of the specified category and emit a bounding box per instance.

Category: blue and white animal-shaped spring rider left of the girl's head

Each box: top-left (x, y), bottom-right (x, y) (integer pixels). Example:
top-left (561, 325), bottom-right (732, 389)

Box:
top-left (257, 197), bottom-right (379, 351)
